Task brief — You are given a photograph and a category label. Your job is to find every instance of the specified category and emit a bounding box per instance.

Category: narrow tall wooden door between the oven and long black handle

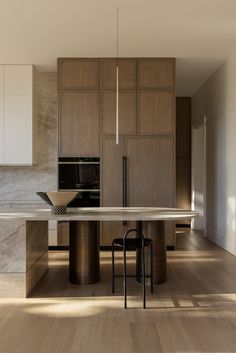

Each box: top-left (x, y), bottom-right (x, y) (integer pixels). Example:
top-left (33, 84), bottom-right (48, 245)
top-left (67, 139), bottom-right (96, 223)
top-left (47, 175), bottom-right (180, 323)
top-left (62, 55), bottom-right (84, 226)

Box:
top-left (101, 137), bottom-right (124, 245)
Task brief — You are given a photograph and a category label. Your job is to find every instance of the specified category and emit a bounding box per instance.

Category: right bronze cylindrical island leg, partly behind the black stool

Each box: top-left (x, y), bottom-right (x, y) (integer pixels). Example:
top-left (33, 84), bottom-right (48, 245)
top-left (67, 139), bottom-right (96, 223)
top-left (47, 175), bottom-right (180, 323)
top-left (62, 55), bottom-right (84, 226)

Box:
top-left (136, 221), bottom-right (167, 284)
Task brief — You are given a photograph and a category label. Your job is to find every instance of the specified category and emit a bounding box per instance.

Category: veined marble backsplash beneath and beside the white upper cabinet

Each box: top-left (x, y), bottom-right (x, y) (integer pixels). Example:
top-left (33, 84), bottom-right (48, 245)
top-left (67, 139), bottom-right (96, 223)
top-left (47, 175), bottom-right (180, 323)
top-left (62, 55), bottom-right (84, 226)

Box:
top-left (0, 72), bottom-right (58, 207)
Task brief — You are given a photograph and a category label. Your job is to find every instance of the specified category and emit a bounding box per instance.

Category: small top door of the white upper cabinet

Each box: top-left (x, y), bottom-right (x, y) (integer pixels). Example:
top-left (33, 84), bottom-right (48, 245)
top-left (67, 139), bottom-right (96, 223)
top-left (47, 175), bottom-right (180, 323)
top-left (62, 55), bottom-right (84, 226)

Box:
top-left (4, 65), bottom-right (33, 94)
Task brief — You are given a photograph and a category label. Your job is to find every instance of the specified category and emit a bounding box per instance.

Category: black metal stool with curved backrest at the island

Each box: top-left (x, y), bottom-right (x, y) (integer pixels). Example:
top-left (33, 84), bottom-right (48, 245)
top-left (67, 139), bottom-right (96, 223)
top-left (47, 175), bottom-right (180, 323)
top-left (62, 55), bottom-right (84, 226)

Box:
top-left (112, 229), bottom-right (153, 309)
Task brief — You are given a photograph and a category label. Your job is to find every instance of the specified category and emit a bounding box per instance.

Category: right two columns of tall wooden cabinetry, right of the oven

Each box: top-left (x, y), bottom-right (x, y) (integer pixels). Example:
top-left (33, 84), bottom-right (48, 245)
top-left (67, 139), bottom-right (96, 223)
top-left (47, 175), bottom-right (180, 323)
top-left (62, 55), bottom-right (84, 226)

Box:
top-left (100, 59), bottom-right (175, 246)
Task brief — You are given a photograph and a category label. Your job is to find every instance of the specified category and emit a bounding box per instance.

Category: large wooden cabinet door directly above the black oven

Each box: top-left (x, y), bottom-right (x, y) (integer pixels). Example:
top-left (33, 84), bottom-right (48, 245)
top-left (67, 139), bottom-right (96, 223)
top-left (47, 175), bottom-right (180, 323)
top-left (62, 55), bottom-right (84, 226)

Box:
top-left (59, 90), bottom-right (99, 156)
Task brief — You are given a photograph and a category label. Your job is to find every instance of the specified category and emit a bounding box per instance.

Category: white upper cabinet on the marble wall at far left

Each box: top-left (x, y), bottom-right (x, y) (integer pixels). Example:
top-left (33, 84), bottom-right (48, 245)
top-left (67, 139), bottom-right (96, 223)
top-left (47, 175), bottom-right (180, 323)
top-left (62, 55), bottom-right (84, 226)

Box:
top-left (0, 65), bottom-right (37, 166)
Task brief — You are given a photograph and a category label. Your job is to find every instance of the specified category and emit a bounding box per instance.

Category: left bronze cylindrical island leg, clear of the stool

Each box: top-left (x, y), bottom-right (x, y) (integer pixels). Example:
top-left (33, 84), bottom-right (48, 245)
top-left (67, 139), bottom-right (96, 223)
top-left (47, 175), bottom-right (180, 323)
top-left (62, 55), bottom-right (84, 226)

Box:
top-left (69, 221), bottom-right (100, 284)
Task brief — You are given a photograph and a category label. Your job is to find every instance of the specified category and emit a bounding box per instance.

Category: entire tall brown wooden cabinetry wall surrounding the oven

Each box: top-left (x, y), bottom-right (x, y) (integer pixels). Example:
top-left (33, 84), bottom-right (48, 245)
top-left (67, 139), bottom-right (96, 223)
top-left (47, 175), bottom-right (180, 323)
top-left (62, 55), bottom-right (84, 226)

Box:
top-left (58, 58), bottom-right (175, 246)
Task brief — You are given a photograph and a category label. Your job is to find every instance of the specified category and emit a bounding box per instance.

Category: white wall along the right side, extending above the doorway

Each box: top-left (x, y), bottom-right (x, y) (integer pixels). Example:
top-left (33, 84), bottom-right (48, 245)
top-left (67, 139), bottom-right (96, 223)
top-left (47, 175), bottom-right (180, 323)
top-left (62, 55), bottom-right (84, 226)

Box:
top-left (192, 53), bottom-right (236, 255)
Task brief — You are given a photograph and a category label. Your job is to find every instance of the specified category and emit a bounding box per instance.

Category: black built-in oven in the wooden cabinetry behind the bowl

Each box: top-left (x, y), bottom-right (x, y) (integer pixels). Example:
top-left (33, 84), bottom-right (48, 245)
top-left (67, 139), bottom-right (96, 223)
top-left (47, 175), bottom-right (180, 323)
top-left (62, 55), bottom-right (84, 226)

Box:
top-left (58, 157), bottom-right (100, 207)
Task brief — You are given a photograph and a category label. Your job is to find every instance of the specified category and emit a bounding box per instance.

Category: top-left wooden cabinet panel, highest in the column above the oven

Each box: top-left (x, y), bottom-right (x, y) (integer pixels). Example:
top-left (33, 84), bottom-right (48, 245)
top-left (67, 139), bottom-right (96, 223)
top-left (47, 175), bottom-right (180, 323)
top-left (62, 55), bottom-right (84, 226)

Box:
top-left (58, 59), bottom-right (99, 89)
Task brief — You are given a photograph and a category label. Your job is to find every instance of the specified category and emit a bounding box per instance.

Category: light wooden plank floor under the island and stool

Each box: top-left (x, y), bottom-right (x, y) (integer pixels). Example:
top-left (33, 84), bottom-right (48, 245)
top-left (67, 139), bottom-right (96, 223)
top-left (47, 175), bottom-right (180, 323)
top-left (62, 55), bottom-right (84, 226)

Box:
top-left (0, 231), bottom-right (236, 353)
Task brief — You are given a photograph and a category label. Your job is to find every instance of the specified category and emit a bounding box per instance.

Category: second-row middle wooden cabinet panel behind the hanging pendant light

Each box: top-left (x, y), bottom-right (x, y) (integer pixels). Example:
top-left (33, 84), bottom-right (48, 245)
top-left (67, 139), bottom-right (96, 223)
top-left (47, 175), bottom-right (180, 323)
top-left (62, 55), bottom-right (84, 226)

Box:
top-left (101, 90), bottom-right (136, 135)
